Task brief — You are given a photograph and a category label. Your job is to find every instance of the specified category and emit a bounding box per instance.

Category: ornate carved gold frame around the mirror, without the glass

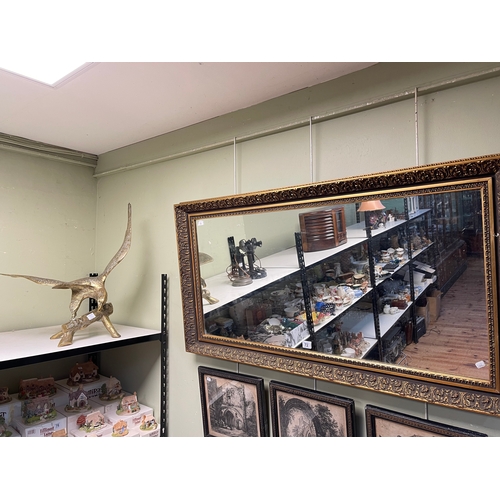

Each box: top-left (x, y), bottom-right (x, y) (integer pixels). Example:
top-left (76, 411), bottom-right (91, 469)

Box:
top-left (174, 155), bottom-right (500, 416)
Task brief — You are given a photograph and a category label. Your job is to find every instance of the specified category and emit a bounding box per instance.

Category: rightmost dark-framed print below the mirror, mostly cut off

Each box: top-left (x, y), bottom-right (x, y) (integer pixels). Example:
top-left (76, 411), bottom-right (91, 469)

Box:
top-left (365, 405), bottom-right (487, 437)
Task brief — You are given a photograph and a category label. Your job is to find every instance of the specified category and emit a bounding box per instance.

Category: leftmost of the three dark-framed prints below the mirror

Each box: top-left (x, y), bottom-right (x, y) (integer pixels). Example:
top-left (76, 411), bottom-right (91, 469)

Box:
top-left (198, 366), bottom-right (268, 437)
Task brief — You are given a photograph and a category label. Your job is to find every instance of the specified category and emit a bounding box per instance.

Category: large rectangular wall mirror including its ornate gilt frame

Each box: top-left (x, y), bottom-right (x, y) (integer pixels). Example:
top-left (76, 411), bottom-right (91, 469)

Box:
top-left (175, 156), bottom-right (500, 415)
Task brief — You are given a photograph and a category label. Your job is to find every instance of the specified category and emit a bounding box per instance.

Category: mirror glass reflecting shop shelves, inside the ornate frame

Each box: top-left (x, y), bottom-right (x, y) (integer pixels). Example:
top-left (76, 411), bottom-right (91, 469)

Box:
top-left (195, 183), bottom-right (494, 381)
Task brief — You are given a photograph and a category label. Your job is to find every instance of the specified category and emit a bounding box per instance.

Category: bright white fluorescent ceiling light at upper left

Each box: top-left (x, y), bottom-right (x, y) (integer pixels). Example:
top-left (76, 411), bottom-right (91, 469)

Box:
top-left (0, 60), bottom-right (87, 85)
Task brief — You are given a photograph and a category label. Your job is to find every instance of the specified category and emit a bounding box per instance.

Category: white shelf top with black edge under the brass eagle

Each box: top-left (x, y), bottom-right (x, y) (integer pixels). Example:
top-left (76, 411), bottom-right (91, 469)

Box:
top-left (0, 323), bottom-right (159, 368)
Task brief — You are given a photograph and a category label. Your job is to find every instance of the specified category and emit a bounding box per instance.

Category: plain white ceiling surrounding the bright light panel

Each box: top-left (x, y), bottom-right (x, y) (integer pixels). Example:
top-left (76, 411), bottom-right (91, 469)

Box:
top-left (0, 62), bottom-right (375, 155)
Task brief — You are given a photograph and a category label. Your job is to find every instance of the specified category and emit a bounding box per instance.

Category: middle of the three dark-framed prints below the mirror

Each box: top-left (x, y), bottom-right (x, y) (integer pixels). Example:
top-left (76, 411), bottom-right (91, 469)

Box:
top-left (269, 380), bottom-right (354, 437)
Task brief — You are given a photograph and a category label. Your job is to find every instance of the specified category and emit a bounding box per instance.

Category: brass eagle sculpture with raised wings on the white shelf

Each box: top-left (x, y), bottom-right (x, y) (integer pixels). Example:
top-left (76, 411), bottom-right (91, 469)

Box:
top-left (0, 203), bottom-right (132, 347)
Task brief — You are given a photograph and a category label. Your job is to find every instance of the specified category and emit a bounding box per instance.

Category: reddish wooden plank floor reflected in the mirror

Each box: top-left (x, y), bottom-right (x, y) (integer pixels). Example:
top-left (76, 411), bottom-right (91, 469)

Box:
top-left (397, 256), bottom-right (489, 380)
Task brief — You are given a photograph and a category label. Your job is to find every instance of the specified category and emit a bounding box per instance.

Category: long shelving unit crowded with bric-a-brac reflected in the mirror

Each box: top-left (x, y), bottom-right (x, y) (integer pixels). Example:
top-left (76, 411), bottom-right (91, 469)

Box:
top-left (203, 199), bottom-right (434, 362)
